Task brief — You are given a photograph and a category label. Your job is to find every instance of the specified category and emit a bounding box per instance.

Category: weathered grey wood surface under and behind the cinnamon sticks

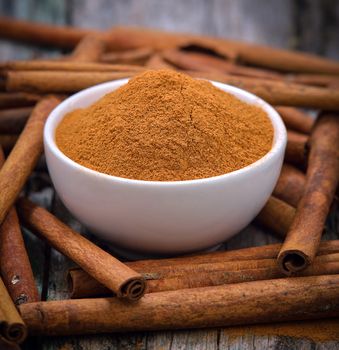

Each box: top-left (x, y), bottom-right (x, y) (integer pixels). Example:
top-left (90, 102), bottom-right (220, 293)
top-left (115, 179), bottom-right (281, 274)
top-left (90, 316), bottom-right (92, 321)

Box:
top-left (0, 0), bottom-right (339, 350)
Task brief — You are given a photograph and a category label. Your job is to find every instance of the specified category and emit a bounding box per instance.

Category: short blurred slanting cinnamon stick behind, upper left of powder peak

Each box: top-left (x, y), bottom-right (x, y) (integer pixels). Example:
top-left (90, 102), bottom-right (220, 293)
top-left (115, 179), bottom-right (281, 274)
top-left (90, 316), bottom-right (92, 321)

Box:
top-left (67, 34), bottom-right (106, 62)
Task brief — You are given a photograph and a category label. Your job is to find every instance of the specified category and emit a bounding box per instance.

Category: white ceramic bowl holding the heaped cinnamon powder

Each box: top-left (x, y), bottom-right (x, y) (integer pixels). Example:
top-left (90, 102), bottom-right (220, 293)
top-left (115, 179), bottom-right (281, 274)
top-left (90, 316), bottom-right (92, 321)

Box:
top-left (44, 79), bottom-right (286, 254)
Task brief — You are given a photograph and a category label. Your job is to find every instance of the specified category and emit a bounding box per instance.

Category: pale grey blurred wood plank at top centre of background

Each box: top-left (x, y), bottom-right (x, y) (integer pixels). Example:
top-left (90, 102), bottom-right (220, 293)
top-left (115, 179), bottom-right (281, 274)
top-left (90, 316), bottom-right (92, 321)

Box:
top-left (72, 0), bottom-right (213, 34)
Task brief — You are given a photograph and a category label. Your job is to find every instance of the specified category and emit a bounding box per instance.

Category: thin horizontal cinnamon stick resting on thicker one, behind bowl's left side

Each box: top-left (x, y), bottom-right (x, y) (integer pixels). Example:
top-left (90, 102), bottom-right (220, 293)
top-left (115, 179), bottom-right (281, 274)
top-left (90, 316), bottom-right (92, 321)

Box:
top-left (4, 60), bottom-right (145, 72)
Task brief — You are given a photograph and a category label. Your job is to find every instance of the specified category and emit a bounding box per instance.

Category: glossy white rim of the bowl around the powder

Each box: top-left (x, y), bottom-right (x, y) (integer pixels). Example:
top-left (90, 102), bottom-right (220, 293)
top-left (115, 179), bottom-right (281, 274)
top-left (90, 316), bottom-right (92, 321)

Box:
top-left (44, 78), bottom-right (287, 187)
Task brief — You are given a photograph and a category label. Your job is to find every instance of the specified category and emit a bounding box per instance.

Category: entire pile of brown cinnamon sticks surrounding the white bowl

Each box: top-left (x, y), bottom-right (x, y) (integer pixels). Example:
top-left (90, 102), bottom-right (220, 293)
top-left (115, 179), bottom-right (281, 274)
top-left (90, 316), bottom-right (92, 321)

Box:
top-left (0, 18), bottom-right (339, 343)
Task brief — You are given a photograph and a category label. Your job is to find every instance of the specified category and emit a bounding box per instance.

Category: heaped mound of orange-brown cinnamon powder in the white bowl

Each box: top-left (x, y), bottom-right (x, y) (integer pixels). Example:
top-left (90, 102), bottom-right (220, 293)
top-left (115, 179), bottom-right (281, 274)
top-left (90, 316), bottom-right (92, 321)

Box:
top-left (56, 70), bottom-right (273, 181)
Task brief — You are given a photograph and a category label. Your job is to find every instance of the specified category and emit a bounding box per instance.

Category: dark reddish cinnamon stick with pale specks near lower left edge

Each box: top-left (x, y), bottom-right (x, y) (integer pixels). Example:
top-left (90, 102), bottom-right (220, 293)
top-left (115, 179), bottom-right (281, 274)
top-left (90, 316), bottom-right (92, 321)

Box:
top-left (0, 147), bottom-right (40, 305)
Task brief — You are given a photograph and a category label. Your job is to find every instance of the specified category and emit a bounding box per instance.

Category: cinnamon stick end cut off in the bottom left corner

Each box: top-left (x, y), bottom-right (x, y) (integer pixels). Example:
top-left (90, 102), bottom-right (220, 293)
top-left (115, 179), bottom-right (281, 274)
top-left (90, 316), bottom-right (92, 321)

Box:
top-left (0, 278), bottom-right (27, 343)
